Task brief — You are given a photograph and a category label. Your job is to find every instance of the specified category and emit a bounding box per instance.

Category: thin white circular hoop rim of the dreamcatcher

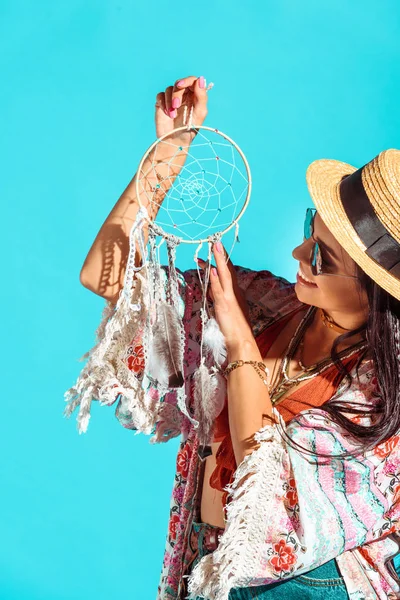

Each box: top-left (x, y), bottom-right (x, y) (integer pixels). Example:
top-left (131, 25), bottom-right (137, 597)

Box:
top-left (135, 119), bottom-right (252, 245)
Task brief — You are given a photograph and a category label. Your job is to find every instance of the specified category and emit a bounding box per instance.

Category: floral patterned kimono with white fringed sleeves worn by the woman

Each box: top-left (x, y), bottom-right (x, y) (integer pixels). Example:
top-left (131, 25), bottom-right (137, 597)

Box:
top-left (110, 266), bottom-right (400, 600)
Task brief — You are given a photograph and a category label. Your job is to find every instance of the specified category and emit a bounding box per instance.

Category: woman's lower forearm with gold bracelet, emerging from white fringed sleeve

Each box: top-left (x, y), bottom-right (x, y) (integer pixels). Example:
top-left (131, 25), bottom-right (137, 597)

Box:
top-left (227, 342), bottom-right (272, 465)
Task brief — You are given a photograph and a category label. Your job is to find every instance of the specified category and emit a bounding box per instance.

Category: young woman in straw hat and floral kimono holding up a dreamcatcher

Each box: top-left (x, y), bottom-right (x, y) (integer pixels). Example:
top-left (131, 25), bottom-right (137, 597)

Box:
top-left (76, 77), bottom-right (400, 600)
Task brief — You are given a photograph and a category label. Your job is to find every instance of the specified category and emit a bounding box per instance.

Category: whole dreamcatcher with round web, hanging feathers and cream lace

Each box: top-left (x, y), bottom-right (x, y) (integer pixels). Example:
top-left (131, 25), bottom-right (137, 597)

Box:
top-left (64, 84), bottom-right (251, 444)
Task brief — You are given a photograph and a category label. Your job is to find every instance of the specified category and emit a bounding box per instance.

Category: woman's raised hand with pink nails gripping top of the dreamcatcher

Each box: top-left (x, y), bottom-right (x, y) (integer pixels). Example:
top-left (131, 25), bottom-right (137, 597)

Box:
top-left (155, 75), bottom-right (207, 143)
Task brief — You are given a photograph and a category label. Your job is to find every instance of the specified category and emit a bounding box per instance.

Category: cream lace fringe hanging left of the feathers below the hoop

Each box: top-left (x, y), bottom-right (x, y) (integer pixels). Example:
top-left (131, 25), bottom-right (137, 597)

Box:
top-left (64, 209), bottom-right (160, 434)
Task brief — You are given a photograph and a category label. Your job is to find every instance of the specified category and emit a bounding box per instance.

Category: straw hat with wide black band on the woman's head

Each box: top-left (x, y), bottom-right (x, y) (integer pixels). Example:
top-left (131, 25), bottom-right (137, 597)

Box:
top-left (306, 149), bottom-right (400, 300)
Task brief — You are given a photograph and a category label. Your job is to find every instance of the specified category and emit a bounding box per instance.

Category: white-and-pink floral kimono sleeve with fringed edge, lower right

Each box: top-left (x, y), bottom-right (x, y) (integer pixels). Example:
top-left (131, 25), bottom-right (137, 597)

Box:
top-left (187, 368), bottom-right (400, 600)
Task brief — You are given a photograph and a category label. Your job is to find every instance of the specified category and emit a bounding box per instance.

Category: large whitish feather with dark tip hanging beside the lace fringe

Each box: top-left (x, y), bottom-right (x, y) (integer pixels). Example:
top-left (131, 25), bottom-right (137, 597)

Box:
top-left (148, 302), bottom-right (184, 388)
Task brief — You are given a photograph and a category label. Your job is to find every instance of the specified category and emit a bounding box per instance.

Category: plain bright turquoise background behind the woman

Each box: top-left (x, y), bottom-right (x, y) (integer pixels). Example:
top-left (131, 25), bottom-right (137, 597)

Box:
top-left (0, 0), bottom-right (400, 600)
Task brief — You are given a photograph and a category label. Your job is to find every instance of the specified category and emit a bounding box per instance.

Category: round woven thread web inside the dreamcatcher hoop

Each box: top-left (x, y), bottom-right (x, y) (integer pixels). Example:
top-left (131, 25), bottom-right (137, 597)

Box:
top-left (138, 128), bottom-right (249, 248)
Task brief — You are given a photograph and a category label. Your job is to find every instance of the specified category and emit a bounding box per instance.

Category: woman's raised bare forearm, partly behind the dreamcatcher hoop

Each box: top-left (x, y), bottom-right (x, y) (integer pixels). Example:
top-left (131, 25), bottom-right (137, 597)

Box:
top-left (80, 139), bottom-right (187, 301)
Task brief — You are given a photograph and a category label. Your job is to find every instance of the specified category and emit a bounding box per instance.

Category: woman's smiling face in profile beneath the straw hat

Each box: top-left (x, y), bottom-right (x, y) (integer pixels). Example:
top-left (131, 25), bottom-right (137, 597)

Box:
top-left (292, 212), bottom-right (368, 313)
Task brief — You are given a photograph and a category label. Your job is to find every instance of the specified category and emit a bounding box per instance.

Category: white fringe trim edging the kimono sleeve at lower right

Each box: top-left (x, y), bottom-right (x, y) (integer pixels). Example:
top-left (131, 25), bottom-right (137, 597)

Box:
top-left (186, 409), bottom-right (285, 600)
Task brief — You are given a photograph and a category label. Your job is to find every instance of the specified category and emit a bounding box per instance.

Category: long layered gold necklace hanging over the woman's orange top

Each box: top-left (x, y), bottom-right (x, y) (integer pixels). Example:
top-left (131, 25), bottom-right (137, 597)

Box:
top-left (268, 306), bottom-right (367, 405)
